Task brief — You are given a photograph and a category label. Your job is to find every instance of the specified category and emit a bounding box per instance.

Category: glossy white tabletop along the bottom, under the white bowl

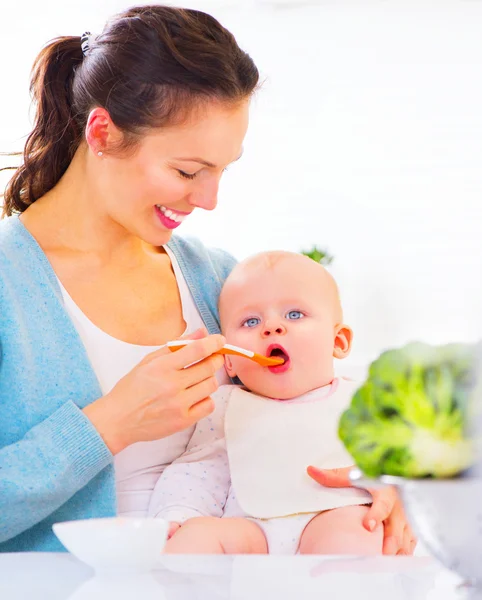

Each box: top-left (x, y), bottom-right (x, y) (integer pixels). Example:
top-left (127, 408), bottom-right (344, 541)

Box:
top-left (0, 553), bottom-right (479, 600)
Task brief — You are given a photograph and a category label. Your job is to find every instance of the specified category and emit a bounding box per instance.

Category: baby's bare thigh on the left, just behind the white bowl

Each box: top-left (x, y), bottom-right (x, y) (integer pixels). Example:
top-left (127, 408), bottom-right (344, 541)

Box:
top-left (165, 517), bottom-right (268, 554)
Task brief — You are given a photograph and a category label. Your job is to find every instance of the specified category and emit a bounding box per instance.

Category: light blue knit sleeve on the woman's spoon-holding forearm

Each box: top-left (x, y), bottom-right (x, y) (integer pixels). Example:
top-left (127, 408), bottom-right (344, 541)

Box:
top-left (0, 402), bottom-right (112, 543)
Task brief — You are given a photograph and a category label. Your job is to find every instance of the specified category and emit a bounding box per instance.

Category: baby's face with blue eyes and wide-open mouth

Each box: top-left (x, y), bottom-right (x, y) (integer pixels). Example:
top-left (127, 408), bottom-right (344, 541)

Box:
top-left (220, 255), bottom-right (350, 399)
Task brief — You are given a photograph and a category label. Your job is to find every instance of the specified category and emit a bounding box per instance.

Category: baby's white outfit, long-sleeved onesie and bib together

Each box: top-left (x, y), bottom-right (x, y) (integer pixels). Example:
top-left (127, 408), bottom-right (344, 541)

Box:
top-left (149, 379), bottom-right (371, 554)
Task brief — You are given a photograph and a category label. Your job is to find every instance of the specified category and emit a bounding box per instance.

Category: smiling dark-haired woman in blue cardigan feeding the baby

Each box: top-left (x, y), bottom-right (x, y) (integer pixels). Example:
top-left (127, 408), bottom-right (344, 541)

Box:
top-left (0, 6), bottom-right (412, 552)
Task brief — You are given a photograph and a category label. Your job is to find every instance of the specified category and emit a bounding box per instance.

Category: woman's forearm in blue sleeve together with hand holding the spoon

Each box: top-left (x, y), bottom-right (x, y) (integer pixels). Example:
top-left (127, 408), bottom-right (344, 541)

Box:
top-left (0, 331), bottom-right (225, 543)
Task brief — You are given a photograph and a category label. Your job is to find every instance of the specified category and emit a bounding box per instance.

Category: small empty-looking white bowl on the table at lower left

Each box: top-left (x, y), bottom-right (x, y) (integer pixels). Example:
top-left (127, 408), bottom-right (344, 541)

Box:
top-left (52, 517), bottom-right (169, 572)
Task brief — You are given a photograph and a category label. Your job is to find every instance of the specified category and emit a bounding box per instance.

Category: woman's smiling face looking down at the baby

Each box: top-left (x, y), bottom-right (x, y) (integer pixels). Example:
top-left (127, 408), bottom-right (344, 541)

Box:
top-left (96, 101), bottom-right (249, 246)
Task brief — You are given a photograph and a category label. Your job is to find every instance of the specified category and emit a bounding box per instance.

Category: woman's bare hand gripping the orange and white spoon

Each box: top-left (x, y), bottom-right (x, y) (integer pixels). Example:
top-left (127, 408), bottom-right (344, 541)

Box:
top-left (84, 330), bottom-right (226, 454)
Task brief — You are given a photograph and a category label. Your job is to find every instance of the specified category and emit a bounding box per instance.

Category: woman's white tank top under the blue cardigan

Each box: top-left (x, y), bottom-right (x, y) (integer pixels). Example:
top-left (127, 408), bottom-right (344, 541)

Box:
top-left (59, 246), bottom-right (230, 516)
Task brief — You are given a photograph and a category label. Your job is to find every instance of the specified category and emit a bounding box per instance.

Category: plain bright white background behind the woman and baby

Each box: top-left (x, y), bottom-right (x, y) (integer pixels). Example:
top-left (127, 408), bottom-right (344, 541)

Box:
top-left (0, 0), bottom-right (482, 372)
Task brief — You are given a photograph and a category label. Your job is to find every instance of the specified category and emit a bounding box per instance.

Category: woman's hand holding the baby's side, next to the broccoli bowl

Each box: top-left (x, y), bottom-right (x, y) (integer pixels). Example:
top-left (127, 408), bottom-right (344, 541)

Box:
top-left (308, 467), bottom-right (417, 555)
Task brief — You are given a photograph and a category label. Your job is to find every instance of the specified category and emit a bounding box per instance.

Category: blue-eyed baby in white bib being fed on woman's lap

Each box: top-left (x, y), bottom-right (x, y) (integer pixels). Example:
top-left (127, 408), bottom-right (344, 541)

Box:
top-left (149, 252), bottom-right (383, 555)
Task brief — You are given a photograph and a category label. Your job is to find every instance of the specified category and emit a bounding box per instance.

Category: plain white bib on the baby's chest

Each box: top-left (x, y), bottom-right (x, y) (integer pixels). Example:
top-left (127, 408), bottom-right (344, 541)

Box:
top-left (225, 379), bottom-right (371, 519)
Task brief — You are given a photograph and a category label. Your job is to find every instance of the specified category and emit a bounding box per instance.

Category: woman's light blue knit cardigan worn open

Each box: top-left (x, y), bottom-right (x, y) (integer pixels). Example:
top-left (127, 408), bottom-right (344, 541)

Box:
top-left (0, 216), bottom-right (235, 552)
